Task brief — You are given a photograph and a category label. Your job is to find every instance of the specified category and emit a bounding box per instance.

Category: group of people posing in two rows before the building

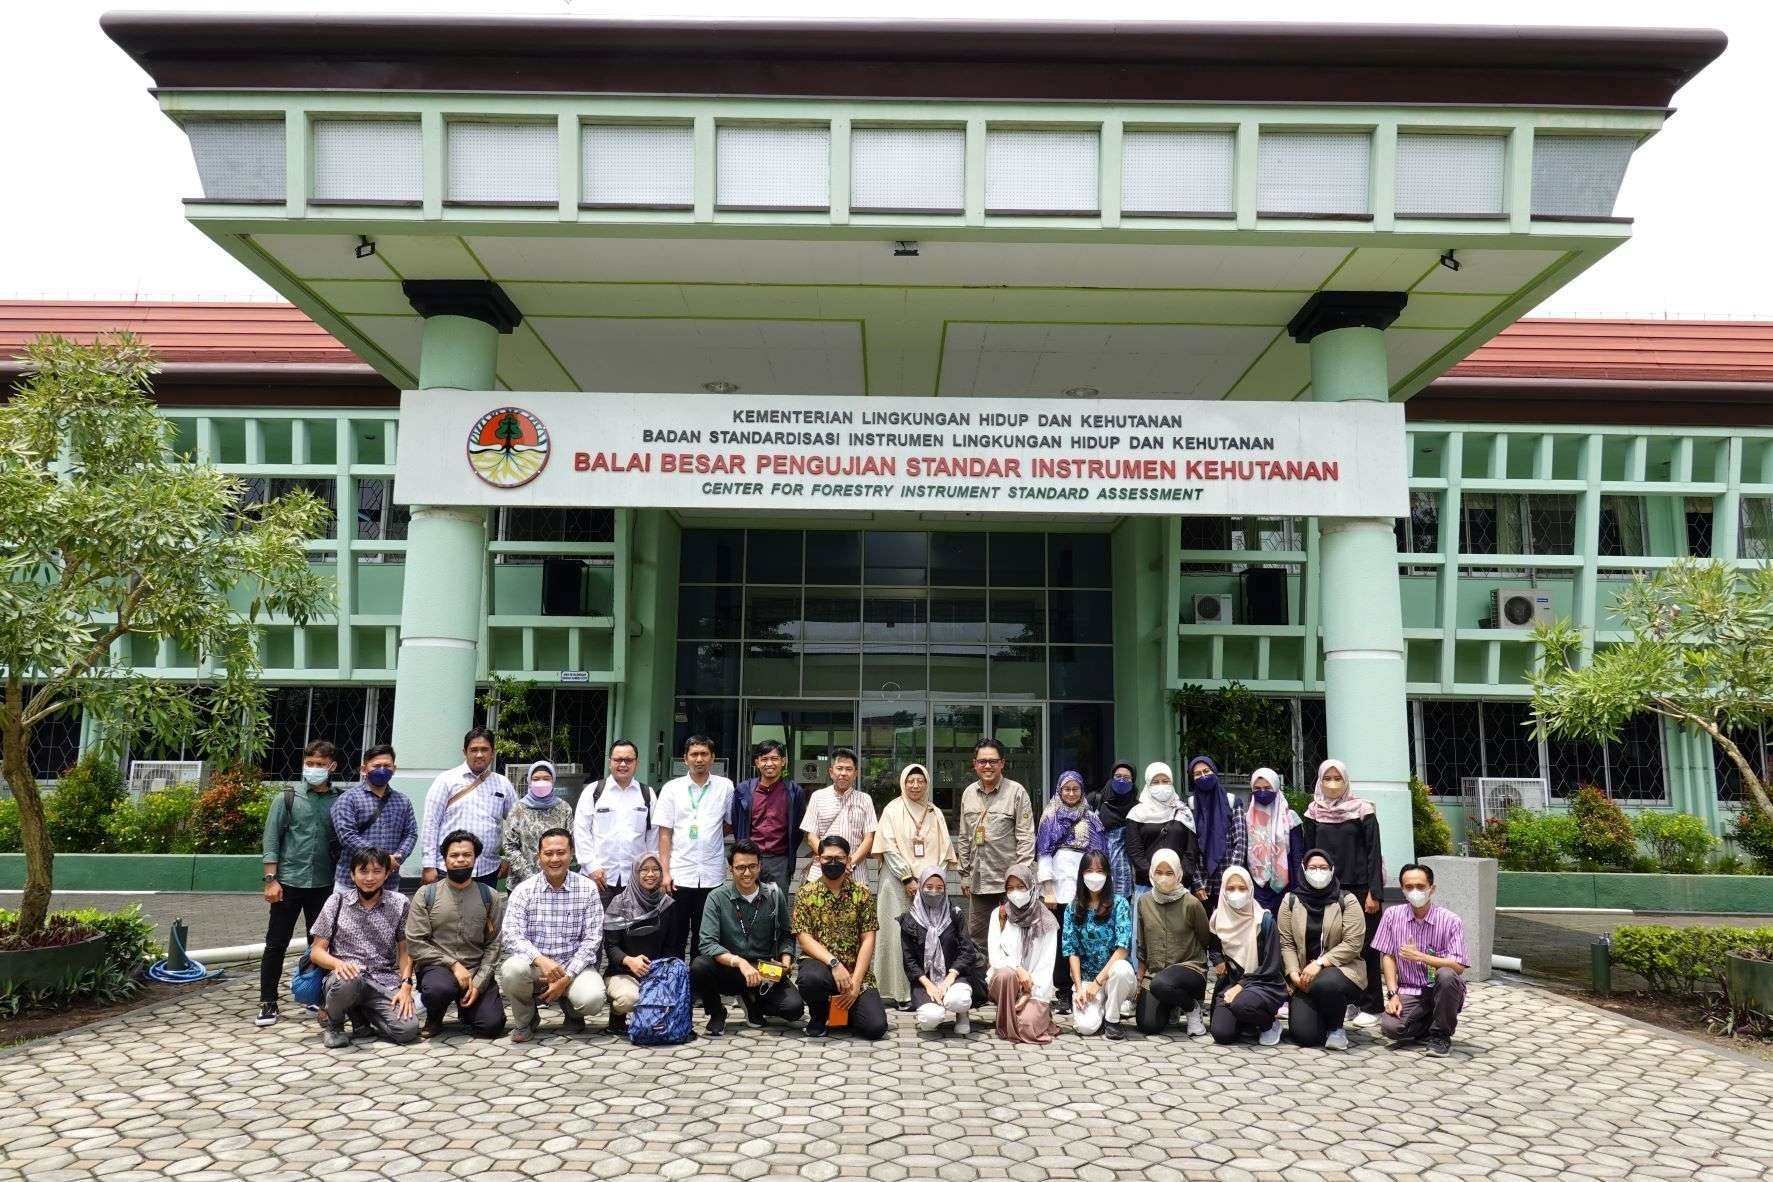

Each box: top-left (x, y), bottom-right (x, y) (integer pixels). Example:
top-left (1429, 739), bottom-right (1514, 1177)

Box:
top-left (257, 728), bottom-right (1468, 1054)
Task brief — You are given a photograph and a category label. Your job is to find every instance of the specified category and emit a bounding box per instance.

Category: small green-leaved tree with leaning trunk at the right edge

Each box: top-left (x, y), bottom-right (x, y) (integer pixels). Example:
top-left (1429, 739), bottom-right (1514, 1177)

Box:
top-left (1528, 558), bottom-right (1773, 817)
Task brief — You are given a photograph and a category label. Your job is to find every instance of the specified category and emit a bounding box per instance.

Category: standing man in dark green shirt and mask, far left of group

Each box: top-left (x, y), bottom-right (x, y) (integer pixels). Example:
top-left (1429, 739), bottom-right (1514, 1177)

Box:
top-left (254, 739), bottom-right (339, 1026)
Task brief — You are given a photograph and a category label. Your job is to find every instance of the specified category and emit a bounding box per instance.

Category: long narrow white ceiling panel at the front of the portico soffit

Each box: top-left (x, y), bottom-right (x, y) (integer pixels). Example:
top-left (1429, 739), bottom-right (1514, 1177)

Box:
top-left (453, 237), bottom-right (1347, 292)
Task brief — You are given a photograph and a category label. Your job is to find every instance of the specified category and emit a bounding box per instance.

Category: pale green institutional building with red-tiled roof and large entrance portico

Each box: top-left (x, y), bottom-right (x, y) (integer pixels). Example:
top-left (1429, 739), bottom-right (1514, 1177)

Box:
top-left (20, 14), bottom-right (1751, 867)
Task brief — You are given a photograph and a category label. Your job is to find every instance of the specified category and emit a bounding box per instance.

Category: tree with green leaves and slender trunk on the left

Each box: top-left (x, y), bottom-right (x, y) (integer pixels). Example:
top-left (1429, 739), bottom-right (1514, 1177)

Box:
top-left (0, 333), bottom-right (335, 934)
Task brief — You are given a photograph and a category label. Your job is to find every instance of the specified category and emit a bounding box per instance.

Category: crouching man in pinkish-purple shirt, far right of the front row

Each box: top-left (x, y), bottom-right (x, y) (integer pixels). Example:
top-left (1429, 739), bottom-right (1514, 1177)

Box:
top-left (1372, 863), bottom-right (1472, 1056)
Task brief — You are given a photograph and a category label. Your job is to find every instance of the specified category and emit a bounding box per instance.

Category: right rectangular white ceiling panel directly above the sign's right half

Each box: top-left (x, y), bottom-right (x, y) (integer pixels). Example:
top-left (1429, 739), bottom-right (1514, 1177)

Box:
top-left (938, 324), bottom-right (1275, 399)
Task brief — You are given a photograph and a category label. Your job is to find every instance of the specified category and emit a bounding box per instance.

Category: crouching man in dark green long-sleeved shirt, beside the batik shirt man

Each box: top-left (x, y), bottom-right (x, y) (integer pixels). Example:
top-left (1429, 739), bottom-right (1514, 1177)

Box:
top-left (690, 842), bottom-right (807, 1038)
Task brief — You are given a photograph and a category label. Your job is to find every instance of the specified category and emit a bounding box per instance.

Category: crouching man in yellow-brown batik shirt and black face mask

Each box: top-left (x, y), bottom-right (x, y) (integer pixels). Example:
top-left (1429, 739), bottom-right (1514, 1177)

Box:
top-left (793, 833), bottom-right (887, 1040)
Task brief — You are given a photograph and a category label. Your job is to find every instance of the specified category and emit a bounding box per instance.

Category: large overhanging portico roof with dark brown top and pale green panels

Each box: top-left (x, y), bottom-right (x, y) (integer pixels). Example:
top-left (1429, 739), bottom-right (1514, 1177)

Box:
top-left (105, 16), bottom-right (1723, 399)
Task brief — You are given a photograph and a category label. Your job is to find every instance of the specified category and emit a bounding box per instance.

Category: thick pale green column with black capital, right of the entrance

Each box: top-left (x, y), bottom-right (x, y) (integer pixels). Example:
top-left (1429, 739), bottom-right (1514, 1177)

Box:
top-left (1287, 292), bottom-right (1411, 883)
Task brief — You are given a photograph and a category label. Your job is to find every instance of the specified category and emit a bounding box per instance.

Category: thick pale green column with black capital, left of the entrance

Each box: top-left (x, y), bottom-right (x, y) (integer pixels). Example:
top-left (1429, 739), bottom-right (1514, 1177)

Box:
top-left (394, 280), bottom-right (519, 808)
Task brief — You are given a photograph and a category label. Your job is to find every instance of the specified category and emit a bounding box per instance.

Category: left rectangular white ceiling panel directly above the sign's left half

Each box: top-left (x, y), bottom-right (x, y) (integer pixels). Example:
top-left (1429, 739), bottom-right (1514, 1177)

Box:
top-left (527, 317), bottom-right (865, 395)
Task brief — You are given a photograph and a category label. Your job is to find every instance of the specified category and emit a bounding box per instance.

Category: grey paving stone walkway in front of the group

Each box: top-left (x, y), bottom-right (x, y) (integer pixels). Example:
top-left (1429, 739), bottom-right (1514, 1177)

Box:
top-left (0, 980), bottom-right (1773, 1182)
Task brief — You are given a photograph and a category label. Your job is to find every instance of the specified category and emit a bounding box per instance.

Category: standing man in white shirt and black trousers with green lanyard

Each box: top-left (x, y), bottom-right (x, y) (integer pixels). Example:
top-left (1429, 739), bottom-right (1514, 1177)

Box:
top-left (652, 735), bottom-right (732, 955)
